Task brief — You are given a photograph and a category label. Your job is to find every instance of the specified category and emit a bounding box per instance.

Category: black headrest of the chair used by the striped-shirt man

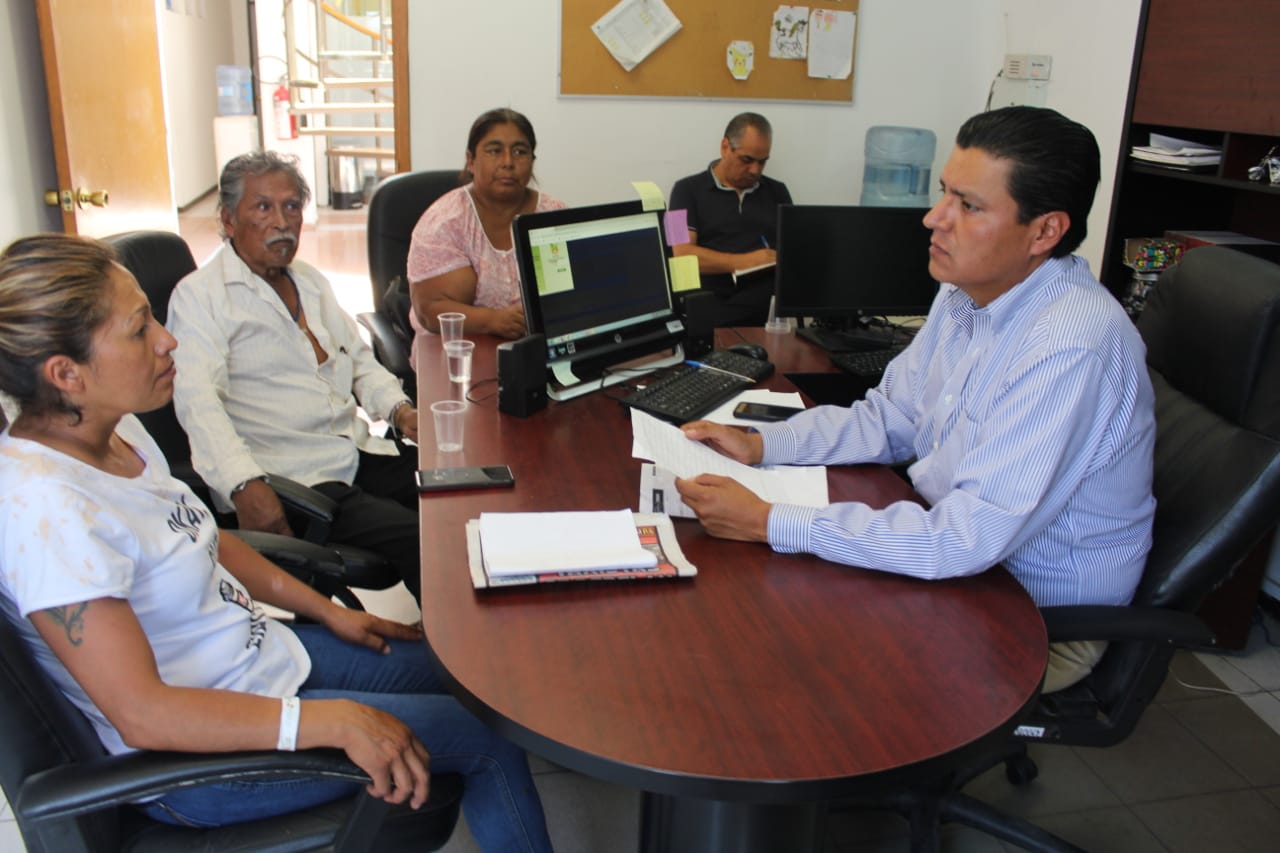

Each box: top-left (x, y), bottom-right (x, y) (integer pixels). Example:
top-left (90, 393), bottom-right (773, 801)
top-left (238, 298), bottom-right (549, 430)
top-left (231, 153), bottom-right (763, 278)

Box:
top-left (1138, 246), bottom-right (1280, 437)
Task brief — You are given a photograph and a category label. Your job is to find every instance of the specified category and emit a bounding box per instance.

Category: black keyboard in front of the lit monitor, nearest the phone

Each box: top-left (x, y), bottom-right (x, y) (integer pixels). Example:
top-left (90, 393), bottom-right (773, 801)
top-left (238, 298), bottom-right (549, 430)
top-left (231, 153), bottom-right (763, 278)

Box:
top-left (621, 350), bottom-right (773, 424)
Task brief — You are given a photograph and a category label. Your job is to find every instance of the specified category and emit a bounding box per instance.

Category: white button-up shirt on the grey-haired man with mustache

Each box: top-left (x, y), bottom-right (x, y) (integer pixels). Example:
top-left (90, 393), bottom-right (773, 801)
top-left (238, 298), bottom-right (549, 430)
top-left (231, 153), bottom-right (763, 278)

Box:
top-left (168, 242), bottom-right (406, 508)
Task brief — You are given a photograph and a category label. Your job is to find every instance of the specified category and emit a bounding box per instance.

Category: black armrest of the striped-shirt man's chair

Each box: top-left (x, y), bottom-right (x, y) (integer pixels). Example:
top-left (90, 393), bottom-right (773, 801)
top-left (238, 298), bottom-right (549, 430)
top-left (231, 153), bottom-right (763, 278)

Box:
top-left (1041, 605), bottom-right (1216, 647)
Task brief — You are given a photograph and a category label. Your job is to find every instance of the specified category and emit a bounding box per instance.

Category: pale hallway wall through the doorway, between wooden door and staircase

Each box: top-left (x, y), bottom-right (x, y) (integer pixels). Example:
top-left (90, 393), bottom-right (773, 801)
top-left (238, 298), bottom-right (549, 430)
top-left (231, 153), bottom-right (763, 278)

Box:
top-left (156, 0), bottom-right (240, 207)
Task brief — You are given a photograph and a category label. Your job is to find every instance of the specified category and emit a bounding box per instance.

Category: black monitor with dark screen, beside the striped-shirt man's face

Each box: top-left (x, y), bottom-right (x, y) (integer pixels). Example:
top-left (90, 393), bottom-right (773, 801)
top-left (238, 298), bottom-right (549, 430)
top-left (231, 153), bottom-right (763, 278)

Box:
top-left (776, 205), bottom-right (938, 325)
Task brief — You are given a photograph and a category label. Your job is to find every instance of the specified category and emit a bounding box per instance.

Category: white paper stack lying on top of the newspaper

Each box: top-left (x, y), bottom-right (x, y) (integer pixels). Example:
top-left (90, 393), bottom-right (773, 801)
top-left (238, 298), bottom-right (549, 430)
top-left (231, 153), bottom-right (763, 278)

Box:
top-left (480, 510), bottom-right (658, 578)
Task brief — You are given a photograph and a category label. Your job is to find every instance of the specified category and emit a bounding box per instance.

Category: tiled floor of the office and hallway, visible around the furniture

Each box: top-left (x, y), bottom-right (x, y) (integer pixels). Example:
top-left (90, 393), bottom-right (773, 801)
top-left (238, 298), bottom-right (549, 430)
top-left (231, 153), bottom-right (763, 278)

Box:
top-left (0, 199), bottom-right (1280, 853)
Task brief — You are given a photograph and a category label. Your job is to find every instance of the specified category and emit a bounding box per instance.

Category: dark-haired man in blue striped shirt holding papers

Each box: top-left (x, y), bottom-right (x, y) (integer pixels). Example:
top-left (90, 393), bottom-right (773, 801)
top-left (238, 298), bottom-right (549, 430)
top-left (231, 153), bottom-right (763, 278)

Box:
top-left (677, 106), bottom-right (1155, 690)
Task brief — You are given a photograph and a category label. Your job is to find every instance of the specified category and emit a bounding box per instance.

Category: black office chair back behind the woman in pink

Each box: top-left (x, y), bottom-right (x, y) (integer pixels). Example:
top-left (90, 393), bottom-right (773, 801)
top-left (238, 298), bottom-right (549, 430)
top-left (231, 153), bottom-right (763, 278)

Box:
top-left (356, 169), bottom-right (458, 397)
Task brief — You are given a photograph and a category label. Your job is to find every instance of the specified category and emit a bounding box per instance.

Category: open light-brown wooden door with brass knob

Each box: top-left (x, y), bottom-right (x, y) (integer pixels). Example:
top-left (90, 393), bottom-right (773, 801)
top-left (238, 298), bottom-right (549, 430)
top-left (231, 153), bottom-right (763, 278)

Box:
top-left (36, 0), bottom-right (178, 237)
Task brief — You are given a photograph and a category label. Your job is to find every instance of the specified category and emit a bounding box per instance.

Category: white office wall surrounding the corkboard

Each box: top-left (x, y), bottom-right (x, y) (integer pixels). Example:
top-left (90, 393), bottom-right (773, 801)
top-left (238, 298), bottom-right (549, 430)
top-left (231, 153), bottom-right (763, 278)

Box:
top-left (408, 0), bottom-right (1140, 269)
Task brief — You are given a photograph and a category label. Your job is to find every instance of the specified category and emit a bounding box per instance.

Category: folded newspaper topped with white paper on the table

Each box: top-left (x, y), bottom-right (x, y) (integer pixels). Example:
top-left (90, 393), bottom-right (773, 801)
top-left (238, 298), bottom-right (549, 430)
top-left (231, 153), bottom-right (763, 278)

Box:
top-left (467, 510), bottom-right (698, 589)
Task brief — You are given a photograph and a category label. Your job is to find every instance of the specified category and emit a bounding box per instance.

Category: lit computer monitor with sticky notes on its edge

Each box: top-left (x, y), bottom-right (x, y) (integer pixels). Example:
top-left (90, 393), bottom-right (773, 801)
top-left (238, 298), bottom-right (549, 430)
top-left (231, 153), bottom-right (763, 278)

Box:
top-left (513, 201), bottom-right (685, 400)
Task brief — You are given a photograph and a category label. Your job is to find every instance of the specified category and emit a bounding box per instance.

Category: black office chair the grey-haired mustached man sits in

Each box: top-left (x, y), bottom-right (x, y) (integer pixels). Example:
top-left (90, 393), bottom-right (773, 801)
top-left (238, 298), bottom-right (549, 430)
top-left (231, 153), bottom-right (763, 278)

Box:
top-left (106, 231), bottom-right (399, 610)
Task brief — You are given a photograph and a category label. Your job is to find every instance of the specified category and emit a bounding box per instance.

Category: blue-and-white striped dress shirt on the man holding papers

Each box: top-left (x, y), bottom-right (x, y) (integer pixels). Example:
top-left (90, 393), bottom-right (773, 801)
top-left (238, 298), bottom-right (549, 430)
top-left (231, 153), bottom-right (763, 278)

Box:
top-left (760, 257), bottom-right (1155, 606)
